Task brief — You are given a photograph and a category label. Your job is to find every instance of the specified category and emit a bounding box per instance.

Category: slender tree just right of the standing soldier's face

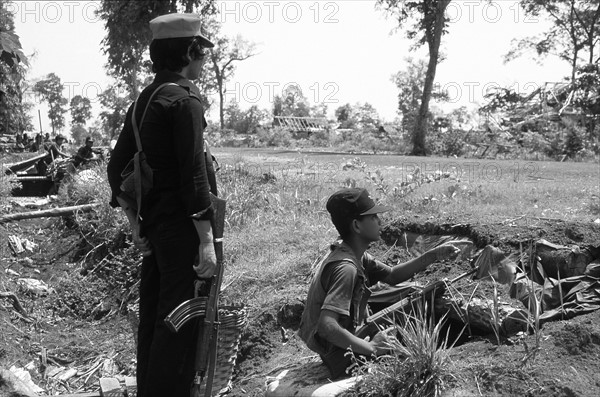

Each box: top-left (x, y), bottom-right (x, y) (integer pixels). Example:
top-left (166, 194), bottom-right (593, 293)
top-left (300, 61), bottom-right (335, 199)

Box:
top-left (206, 18), bottom-right (256, 128)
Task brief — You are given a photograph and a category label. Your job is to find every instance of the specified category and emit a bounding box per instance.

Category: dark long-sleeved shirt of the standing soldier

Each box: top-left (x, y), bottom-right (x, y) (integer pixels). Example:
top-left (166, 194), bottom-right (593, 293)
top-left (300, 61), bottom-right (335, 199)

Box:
top-left (107, 71), bottom-right (212, 225)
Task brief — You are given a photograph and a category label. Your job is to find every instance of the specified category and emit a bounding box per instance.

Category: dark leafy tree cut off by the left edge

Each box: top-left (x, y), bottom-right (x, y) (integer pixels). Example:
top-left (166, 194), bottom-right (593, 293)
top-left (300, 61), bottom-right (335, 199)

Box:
top-left (0, 0), bottom-right (33, 134)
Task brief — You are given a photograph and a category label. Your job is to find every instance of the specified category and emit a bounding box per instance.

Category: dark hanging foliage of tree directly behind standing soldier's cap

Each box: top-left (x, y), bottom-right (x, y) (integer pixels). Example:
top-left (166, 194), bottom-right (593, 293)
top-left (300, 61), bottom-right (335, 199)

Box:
top-left (97, 0), bottom-right (217, 100)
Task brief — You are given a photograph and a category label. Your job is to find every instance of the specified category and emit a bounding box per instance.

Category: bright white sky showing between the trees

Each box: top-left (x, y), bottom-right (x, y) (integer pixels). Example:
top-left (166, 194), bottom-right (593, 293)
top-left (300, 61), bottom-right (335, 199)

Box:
top-left (10, 0), bottom-right (569, 135)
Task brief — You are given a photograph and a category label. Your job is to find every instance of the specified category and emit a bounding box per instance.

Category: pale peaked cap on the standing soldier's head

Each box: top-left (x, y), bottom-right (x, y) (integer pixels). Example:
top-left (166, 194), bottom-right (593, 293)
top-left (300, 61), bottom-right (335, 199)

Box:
top-left (150, 13), bottom-right (215, 48)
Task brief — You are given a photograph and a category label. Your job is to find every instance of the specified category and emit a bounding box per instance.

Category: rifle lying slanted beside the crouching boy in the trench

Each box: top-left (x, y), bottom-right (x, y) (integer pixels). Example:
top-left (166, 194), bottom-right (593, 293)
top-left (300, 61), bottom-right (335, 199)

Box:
top-left (354, 268), bottom-right (477, 339)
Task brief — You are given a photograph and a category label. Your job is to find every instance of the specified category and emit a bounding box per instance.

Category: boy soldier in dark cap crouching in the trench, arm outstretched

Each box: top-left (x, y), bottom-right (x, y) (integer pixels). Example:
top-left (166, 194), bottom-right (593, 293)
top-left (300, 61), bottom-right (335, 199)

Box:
top-left (298, 188), bottom-right (460, 379)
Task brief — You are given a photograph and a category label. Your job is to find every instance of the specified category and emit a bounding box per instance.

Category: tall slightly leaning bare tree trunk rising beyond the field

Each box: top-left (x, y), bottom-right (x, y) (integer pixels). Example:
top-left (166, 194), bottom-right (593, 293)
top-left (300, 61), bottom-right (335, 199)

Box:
top-left (412, 0), bottom-right (450, 156)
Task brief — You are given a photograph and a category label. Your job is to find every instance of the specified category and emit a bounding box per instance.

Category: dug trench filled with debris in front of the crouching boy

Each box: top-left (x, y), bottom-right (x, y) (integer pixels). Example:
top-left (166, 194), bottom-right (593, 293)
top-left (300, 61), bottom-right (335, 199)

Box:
top-left (370, 222), bottom-right (600, 346)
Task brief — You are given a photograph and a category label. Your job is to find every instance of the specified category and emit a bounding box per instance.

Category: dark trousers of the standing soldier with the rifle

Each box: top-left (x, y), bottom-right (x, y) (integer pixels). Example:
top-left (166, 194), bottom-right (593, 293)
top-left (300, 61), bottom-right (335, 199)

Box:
top-left (137, 218), bottom-right (199, 397)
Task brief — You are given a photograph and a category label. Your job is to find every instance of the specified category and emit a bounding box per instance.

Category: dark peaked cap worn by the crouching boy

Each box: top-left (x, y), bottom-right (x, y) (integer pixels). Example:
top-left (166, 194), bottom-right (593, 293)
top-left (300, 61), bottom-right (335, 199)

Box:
top-left (326, 188), bottom-right (392, 219)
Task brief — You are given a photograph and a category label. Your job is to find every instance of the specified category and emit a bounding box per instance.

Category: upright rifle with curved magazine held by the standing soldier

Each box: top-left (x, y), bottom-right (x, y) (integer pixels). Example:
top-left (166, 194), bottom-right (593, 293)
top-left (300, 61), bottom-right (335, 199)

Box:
top-left (165, 194), bottom-right (226, 397)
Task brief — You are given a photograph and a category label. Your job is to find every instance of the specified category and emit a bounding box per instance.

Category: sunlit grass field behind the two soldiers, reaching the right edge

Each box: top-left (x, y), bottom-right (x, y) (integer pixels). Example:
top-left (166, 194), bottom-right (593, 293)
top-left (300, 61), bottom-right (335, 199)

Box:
top-left (214, 149), bottom-right (600, 309)
